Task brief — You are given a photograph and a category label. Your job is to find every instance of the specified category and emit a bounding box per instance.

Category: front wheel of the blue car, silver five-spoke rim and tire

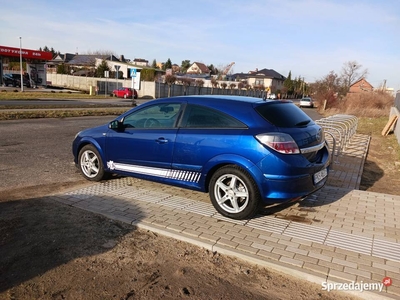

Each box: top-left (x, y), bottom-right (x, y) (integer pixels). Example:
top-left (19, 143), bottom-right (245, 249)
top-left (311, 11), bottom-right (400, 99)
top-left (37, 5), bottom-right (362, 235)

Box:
top-left (78, 145), bottom-right (106, 181)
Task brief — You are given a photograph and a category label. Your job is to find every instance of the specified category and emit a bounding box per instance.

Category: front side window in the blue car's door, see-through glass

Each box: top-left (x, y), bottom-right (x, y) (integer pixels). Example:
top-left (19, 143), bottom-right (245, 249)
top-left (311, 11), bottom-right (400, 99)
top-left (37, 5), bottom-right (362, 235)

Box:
top-left (123, 103), bottom-right (181, 128)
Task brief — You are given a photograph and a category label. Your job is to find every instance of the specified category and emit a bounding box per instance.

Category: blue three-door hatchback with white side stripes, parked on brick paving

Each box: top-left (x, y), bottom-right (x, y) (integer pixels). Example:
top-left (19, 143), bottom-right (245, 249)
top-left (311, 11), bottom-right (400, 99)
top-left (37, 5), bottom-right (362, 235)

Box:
top-left (72, 95), bottom-right (331, 219)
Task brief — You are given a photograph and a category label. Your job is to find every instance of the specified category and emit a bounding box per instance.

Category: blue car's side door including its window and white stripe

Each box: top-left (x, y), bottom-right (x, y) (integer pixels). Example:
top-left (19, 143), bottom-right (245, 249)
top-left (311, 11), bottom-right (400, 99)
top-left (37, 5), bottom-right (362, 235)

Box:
top-left (106, 103), bottom-right (181, 177)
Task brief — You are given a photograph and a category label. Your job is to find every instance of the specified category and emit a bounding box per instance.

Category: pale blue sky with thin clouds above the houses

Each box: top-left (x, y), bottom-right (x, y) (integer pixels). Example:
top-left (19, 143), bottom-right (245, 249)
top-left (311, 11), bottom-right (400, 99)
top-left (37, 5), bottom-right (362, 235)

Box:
top-left (0, 0), bottom-right (400, 90)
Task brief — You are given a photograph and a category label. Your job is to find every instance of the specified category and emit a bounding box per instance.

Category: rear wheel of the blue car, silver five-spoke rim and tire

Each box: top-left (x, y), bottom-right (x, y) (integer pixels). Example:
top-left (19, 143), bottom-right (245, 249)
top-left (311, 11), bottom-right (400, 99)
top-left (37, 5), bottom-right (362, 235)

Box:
top-left (209, 165), bottom-right (261, 220)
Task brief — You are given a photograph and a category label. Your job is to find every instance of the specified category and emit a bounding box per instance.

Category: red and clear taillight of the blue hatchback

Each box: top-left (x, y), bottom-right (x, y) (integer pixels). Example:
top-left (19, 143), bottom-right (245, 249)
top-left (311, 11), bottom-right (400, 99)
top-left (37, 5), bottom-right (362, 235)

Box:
top-left (256, 132), bottom-right (300, 154)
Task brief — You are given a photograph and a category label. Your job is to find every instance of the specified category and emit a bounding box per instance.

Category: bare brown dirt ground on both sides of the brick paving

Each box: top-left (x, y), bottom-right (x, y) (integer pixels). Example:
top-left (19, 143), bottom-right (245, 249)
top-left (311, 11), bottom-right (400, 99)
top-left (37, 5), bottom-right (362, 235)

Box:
top-left (0, 134), bottom-right (400, 299)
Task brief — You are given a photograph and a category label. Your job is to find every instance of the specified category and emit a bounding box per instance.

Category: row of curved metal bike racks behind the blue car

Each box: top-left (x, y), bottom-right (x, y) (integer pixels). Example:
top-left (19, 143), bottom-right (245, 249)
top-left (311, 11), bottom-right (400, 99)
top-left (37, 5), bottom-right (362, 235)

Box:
top-left (316, 115), bottom-right (358, 163)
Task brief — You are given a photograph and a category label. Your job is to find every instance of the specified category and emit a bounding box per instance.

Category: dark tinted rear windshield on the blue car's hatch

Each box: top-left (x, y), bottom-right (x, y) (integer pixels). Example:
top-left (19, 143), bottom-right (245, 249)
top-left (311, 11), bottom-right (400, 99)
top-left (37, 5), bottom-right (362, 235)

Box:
top-left (255, 102), bottom-right (314, 127)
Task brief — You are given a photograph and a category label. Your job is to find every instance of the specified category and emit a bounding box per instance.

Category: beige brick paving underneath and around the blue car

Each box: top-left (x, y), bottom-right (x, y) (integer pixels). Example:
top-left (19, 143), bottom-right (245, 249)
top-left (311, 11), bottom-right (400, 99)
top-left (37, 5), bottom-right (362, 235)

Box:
top-left (53, 134), bottom-right (400, 299)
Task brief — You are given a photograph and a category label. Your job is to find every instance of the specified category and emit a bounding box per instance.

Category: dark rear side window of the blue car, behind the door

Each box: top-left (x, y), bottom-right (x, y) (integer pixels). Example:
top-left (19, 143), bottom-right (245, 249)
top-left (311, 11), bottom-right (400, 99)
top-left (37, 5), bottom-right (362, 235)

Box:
top-left (183, 105), bottom-right (246, 128)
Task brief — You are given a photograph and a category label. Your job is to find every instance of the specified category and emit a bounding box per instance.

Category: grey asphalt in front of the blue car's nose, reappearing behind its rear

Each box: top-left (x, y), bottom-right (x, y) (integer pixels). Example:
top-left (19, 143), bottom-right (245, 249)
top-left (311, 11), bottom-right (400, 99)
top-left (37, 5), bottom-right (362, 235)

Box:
top-left (0, 109), bottom-right (320, 193)
